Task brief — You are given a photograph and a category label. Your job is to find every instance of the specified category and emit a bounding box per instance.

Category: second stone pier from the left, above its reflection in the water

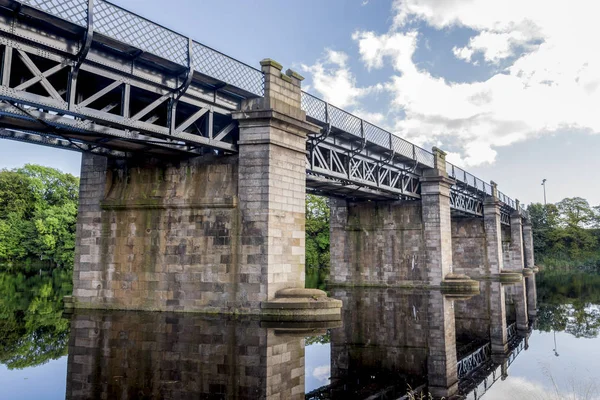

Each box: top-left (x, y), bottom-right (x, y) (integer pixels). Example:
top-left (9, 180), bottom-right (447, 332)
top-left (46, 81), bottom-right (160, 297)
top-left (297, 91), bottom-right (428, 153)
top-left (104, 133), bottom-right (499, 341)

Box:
top-left (330, 148), bottom-right (478, 291)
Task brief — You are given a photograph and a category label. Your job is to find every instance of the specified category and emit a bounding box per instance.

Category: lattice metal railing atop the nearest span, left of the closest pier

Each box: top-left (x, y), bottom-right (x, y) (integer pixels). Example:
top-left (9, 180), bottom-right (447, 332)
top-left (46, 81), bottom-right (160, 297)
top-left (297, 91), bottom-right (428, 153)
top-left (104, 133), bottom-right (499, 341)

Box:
top-left (20, 0), bottom-right (264, 96)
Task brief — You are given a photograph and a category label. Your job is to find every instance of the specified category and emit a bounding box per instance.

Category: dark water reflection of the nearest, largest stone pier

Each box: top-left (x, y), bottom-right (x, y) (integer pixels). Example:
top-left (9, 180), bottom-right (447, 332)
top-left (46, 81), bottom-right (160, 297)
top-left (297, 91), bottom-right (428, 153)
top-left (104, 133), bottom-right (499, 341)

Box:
top-left (66, 311), bottom-right (316, 400)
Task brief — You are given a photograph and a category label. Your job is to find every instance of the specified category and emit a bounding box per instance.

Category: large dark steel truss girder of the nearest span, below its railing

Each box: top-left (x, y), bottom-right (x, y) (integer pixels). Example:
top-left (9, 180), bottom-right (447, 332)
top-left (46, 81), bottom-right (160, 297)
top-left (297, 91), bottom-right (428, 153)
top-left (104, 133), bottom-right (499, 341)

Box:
top-left (0, 16), bottom-right (239, 155)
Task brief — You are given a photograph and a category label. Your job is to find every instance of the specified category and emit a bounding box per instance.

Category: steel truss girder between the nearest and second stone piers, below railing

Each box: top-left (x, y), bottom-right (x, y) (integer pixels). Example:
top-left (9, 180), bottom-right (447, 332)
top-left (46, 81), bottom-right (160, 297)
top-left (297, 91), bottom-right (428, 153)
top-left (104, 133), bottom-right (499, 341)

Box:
top-left (307, 137), bottom-right (421, 199)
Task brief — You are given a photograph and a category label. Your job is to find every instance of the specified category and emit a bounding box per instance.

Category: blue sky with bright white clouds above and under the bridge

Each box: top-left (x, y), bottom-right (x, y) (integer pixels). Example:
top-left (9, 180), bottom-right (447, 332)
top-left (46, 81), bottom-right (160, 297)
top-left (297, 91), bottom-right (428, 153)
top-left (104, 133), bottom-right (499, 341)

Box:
top-left (0, 0), bottom-right (600, 205)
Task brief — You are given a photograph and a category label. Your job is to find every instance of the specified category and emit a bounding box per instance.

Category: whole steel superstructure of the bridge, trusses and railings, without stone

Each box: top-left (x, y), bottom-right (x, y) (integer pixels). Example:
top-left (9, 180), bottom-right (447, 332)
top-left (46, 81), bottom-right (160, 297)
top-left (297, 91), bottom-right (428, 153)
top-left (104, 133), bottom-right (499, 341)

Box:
top-left (0, 0), bottom-right (526, 224)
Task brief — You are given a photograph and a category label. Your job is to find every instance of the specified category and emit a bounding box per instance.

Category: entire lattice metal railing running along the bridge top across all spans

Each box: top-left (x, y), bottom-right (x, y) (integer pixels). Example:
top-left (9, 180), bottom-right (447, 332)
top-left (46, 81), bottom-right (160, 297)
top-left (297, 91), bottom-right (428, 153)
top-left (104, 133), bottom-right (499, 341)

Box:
top-left (14, 0), bottom-right (528, 216)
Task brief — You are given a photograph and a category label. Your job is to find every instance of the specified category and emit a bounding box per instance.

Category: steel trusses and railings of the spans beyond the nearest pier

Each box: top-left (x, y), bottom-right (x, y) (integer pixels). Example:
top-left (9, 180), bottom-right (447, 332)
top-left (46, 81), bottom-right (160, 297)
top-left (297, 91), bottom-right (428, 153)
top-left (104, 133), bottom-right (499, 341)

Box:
top-left (301, 92), bottom-right (515, 216)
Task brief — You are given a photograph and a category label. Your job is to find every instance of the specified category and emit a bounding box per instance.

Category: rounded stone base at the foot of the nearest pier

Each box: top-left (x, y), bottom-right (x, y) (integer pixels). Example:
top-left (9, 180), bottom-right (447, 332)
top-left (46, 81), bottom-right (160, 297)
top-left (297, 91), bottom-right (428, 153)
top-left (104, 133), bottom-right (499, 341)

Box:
top-left (260, 288), bottom-right (342, 321)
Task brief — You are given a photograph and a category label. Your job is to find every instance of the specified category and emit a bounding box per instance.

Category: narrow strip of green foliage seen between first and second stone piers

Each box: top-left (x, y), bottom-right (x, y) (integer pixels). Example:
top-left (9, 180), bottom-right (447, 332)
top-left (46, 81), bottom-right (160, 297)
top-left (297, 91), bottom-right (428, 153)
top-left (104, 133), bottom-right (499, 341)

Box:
top-left (306, 194), bottom-right (329, 289)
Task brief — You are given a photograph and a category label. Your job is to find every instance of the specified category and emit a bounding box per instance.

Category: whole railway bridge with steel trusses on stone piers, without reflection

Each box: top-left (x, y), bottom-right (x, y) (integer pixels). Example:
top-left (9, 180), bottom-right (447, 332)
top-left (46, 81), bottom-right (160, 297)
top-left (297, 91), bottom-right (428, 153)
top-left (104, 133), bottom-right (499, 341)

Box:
top-left (0, 0), bottom-right (534, 319)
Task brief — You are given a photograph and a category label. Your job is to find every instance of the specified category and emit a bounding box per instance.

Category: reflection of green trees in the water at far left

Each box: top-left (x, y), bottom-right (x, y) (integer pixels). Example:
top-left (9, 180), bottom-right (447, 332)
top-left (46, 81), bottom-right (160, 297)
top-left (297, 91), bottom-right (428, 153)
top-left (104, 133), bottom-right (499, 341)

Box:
top-left (0, 269), bottom-right (72, 369)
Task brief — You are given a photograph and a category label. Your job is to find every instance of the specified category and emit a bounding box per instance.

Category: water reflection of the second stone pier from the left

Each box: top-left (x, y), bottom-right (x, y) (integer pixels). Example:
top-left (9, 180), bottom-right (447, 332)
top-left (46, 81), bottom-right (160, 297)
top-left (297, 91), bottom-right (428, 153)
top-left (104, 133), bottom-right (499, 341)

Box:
top-left (330, 287), bottom-right (458, 398)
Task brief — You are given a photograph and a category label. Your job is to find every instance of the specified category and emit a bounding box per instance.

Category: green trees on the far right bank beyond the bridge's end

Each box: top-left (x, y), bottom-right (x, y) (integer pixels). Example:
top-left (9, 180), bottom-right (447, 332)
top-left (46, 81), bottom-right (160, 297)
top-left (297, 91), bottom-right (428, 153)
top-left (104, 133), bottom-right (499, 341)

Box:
top-left (527, 197), bottom-right (600, 269)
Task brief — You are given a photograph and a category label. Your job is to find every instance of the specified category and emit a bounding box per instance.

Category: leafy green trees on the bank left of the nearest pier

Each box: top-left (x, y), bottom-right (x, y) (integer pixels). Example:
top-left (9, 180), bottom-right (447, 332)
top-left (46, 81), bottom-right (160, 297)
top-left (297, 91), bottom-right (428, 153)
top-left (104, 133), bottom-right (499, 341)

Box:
top-left (0, 165), bottom-right (79, 271)
